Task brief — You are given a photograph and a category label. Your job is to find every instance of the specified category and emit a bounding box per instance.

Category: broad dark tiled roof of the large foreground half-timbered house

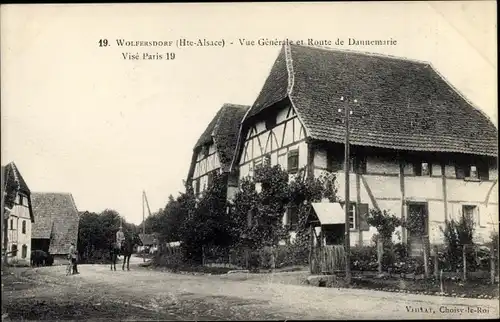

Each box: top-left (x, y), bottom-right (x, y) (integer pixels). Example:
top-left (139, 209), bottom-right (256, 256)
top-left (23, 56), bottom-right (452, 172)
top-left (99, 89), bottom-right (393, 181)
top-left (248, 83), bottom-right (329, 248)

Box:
top-left (246, 45), bottom-right (498, 156)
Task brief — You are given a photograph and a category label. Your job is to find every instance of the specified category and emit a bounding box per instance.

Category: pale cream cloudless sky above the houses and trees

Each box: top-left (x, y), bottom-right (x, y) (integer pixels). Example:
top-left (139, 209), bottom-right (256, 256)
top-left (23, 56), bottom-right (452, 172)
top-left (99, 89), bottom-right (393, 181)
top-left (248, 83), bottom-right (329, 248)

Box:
top-left (0, 1), bottom-right (497, 224)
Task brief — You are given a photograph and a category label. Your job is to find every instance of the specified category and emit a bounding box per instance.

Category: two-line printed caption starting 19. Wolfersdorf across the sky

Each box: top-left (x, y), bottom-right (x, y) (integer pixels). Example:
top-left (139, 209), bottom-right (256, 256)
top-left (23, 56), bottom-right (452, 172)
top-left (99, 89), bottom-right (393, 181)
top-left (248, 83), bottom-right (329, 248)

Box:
top-left (110, 37), bottom-right (398, 60)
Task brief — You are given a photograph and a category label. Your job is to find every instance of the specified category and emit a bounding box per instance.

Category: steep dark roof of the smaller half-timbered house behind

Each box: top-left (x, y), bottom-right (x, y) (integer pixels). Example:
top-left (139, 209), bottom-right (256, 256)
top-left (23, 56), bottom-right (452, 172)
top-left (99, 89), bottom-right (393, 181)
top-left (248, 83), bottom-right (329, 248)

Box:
top-left (188, 104), bottom-right (250, 178)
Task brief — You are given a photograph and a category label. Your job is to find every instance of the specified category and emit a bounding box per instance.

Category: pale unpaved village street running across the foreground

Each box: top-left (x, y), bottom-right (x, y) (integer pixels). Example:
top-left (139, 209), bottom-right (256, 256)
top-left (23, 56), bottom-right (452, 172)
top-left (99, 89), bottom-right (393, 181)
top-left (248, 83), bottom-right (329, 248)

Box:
top-left (3, 260), bottom-right (499, 320)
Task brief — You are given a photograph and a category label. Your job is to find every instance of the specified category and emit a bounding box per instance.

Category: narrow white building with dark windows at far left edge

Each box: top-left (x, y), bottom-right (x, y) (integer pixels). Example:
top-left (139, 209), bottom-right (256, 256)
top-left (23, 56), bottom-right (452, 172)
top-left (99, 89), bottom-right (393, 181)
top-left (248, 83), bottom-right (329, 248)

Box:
top-left (2, 162), bottom-right (34, 264)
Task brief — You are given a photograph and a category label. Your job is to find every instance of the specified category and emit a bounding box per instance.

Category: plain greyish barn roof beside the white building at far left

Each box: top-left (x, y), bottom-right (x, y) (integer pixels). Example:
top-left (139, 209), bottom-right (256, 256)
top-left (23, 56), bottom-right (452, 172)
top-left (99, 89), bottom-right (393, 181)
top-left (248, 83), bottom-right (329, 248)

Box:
top-left (31, 192), bottom-right (79, 254)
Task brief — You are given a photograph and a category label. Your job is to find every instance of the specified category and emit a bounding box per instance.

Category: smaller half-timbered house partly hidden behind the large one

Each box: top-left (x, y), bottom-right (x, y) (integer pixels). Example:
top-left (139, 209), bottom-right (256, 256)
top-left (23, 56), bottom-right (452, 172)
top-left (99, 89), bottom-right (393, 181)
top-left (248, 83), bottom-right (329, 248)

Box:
top-left (187, 104), bottom-right (249, 199)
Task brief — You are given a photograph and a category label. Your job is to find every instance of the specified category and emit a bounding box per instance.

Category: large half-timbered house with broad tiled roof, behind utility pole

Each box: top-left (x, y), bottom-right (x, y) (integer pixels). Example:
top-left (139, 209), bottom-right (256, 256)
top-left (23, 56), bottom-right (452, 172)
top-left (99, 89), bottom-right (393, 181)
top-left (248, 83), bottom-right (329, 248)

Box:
top-left (232, 45), bottom-right (498, 252)
